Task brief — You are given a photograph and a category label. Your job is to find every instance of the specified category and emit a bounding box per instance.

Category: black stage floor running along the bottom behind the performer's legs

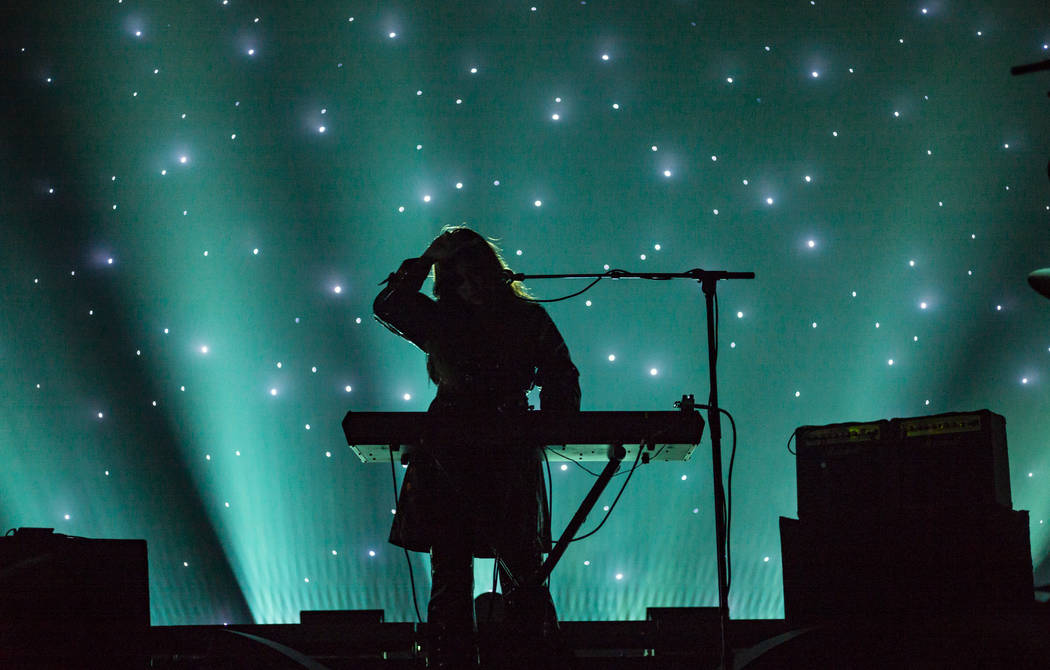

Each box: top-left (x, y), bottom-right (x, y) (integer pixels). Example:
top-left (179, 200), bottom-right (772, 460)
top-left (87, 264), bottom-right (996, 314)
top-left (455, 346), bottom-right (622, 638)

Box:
top-left (6, 605), bottom-right (1050, 670)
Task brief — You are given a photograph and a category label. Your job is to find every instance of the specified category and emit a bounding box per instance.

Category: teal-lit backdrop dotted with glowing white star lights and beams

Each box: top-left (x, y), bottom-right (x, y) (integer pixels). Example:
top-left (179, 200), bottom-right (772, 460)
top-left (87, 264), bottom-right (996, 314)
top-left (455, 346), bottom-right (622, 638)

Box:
top-left (0, 0), bottom-right (1050, 624)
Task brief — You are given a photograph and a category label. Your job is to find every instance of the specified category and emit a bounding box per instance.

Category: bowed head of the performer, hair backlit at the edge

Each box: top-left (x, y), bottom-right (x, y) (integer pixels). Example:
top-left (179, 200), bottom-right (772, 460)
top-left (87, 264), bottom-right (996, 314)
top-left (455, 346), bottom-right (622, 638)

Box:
top-left (434, 226), bottom-right (526, 305)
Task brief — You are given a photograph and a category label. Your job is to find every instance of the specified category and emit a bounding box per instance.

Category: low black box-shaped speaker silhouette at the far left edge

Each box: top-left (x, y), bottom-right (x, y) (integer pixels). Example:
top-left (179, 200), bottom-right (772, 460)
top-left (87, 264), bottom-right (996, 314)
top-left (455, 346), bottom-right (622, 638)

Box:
top-left (0, 528), bottom-right (149, 634)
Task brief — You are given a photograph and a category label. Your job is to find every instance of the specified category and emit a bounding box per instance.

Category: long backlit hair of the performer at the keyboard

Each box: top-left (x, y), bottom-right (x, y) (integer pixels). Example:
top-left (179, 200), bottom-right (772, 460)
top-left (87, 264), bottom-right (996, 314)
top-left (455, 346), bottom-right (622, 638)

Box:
top-left (434, 226), bottom-right (532, 300)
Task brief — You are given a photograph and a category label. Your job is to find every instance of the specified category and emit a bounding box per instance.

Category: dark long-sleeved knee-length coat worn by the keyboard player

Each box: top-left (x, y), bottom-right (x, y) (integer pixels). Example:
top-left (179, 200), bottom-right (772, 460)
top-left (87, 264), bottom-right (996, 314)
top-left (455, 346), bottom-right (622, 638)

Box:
top-left (373, 258), bottom-right (580, 558)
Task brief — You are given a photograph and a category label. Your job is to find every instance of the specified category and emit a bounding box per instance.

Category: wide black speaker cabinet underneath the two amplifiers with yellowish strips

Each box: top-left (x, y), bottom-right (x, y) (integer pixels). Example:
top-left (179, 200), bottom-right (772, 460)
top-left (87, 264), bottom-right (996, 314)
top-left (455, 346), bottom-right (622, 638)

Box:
top-left (780, 512), bottom-right (1034, 623)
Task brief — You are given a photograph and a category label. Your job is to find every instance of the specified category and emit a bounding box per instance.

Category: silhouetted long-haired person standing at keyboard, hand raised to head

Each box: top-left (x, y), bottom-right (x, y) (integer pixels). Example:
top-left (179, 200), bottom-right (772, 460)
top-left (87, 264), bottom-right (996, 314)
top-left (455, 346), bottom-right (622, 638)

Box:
top-left (374, 227), bottom-right (580, 670)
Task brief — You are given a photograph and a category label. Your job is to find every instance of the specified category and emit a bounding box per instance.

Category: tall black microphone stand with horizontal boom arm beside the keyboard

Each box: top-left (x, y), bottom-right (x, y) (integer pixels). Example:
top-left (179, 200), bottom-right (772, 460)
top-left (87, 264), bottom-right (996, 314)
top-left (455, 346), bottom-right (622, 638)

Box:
top-left (507, 269), bottom-right (755, 670)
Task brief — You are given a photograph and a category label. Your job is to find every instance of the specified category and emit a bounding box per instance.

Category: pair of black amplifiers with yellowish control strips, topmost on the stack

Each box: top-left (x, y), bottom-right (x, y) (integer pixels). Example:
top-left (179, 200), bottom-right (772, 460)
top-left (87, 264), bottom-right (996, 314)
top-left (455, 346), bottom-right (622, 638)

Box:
top-left (796, 410), bottom-right (1012, 522)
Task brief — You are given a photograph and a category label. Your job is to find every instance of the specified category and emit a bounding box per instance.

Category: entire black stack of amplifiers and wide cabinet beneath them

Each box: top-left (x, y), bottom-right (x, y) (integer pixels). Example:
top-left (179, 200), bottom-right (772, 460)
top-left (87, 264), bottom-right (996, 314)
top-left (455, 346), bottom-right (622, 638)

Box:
top-left (780, 410), bottom-right (1034, 623)
